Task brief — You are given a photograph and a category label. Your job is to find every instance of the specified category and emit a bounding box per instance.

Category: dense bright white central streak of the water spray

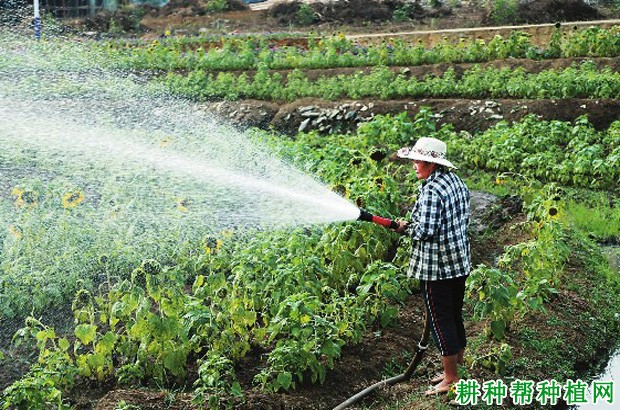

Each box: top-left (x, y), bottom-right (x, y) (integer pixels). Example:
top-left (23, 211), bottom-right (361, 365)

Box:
top-left (0, 99), bottom-right (359, 225)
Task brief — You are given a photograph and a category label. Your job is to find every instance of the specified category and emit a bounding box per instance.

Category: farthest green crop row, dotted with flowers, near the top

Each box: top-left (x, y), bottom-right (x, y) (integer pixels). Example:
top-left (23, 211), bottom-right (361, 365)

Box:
top-left (105, 27), bottom-right (620, 71)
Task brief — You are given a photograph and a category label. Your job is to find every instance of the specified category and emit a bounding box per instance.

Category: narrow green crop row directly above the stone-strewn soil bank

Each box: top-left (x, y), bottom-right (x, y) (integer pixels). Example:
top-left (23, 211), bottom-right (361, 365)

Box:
top-left (162, 61), bottom-right (620, 101)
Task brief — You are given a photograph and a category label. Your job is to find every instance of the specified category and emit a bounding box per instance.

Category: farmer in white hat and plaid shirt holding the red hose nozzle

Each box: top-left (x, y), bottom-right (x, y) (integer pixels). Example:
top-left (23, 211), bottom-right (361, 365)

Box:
top-left (359, 138), bottom-right (470, 395)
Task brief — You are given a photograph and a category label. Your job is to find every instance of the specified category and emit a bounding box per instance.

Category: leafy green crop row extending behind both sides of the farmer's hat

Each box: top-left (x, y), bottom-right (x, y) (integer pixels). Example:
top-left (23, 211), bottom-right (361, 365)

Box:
top-left (288, 109), bottom-right (620, 190)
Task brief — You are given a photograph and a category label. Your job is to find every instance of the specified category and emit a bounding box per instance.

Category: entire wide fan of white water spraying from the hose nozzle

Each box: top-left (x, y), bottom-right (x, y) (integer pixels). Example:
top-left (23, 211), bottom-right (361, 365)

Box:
top-left (0, 35), bottom-right (359, 229)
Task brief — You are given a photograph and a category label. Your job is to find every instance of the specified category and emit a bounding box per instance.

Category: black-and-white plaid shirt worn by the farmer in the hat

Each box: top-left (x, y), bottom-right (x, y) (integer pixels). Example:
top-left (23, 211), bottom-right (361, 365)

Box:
top-left (407, 168), bottom-right (470, 280)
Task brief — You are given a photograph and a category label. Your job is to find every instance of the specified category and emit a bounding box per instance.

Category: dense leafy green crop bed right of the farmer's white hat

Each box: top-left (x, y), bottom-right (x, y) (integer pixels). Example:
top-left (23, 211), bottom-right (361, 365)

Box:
top-left (449, 115), bottom-right (620, 190)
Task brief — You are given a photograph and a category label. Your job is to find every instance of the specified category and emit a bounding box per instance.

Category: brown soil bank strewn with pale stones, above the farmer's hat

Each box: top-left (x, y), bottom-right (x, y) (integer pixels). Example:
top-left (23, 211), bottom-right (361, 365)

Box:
top-left (205, 98), bottom-right (620, 134)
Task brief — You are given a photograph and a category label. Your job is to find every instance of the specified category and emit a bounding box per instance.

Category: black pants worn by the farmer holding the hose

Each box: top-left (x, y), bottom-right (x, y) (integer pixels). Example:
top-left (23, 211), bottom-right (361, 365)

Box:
top-left (420, 276), bottom-right (467, 356)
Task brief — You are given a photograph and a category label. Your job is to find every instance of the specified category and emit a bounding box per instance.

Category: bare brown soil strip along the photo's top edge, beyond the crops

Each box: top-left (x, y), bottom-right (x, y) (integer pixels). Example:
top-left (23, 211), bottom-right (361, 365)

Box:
top-left (133, 0), bottom-right (617, 35)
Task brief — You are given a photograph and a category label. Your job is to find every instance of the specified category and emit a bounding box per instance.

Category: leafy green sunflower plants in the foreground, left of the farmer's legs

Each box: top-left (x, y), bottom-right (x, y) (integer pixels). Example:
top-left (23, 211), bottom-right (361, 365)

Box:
top-left (3, 219), bottom-right (407, 398)
